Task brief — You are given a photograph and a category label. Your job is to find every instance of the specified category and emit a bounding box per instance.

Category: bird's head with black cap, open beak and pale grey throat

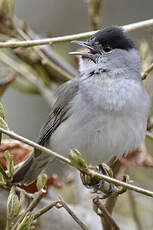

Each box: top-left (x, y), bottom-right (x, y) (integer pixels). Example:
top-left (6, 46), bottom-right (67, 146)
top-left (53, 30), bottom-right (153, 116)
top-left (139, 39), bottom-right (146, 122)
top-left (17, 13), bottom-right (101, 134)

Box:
top-left (70, 26), bottom-right (141, 79)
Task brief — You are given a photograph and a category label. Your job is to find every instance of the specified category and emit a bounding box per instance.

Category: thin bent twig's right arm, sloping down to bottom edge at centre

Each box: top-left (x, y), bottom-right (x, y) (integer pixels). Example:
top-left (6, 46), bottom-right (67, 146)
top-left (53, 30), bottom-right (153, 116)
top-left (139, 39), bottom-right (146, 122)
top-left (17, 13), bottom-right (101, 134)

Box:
top-left (59, 197), bottom-right (88, 230)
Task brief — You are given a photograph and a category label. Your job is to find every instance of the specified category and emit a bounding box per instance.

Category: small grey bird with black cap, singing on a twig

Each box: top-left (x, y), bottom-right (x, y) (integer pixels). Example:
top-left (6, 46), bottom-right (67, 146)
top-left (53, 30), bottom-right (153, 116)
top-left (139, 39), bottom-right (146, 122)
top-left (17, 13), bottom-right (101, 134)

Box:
top-left (13, 26), bottom-right (150, 184)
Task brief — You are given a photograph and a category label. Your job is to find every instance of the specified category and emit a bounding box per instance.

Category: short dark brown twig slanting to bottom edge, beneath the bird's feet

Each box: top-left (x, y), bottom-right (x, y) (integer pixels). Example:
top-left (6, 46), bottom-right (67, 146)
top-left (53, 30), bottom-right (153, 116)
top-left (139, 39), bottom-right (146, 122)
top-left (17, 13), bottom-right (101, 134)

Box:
top-left (93, 197), bottom-right (120, 230)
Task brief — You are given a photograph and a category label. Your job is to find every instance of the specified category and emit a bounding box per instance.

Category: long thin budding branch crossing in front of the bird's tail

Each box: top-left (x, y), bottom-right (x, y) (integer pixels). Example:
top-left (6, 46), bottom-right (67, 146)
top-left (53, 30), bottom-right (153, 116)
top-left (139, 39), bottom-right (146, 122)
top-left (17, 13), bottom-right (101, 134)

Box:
top-left (0, 128), bottom-right (153, 197)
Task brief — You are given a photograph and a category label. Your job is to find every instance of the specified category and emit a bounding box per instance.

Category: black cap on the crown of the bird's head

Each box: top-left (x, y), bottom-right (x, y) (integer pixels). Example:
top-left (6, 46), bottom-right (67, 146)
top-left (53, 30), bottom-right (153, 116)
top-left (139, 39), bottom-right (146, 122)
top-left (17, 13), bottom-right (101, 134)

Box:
top-left (89, 26), bottom-right (135, 50)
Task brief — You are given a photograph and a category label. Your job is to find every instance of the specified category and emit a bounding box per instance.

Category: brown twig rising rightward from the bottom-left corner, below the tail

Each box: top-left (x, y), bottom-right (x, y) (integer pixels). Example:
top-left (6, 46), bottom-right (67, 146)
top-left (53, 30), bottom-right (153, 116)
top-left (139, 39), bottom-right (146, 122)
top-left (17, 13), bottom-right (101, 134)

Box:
top-left (11, 190), bottom-right (44, 230)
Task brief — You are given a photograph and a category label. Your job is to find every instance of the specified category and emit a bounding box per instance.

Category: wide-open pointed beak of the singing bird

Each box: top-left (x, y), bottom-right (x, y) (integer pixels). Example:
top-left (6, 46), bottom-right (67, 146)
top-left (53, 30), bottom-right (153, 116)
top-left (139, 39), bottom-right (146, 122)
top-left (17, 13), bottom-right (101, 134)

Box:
top-left (69, 41), bottom-right (97, 61)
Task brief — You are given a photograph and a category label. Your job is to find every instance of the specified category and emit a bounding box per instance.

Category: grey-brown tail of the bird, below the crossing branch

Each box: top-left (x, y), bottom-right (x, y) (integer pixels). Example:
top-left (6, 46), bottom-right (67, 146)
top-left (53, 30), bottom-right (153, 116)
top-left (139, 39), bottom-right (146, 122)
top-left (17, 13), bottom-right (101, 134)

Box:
top-left (12, 150), bottom-right (49, 185)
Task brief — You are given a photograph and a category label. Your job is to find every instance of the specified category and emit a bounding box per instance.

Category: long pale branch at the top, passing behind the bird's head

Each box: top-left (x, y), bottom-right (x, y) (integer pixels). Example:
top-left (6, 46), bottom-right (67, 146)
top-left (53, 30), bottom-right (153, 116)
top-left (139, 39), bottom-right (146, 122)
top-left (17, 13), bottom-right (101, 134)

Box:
top-left (0, 19), bottom-right (153, 48)
